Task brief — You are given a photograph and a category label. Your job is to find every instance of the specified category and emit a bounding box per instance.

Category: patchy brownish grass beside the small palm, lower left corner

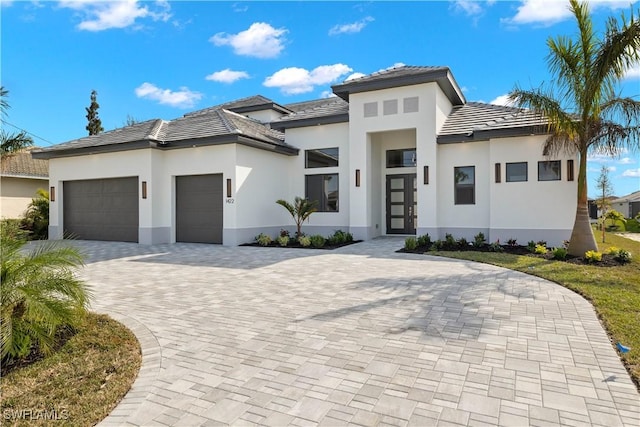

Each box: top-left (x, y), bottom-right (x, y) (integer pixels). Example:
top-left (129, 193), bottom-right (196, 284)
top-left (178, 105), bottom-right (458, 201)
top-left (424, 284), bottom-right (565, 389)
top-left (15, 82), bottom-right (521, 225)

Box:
top-left (0, 313), bottom-right (142, 426)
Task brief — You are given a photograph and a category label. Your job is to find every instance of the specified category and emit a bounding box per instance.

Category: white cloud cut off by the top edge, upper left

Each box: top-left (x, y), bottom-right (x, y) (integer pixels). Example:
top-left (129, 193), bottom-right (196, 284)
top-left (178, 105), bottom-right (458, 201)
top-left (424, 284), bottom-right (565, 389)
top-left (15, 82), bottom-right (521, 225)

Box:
top-left (58, 0), bottom-right (171, 31)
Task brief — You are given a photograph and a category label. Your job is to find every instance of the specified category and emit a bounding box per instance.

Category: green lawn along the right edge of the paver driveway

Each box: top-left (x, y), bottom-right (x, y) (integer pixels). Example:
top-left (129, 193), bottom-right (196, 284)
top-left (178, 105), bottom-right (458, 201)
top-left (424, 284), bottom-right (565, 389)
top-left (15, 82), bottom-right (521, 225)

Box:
top-left (433, 233), bottom-right (640, 389)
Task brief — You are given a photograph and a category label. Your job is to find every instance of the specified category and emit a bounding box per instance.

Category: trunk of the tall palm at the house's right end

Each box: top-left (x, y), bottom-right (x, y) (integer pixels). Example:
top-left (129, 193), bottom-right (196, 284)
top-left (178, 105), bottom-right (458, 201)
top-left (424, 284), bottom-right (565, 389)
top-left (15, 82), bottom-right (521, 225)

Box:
top-left (567, 148), bottom-right (598, 256)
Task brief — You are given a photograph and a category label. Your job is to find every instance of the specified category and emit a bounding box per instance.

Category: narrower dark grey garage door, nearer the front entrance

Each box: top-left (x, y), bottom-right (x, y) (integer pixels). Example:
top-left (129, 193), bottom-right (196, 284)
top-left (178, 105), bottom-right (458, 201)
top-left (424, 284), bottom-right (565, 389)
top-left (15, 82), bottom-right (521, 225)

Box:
top-left (176, 174), bottom-right (223, 243)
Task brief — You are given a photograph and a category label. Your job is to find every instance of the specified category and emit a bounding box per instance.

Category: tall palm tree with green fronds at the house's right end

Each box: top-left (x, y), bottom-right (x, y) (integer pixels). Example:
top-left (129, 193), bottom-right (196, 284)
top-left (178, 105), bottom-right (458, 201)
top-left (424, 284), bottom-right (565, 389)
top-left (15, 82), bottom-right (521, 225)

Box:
top-left (509, 0), bottom-right (640, 256)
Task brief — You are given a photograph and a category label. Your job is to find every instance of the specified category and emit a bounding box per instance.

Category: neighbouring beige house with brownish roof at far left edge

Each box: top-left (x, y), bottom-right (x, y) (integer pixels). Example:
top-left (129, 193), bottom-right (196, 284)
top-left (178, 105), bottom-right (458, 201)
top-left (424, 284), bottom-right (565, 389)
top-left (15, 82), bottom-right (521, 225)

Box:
top-left (0, 150), bottom-right (49, 218)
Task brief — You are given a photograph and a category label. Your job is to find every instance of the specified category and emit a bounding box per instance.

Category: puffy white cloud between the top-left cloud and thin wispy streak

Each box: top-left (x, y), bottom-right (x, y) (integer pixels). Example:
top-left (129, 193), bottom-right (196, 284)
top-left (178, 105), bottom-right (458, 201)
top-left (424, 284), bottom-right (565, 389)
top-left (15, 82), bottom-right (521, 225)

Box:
top-left (209, 22), bottom-right (287, 58)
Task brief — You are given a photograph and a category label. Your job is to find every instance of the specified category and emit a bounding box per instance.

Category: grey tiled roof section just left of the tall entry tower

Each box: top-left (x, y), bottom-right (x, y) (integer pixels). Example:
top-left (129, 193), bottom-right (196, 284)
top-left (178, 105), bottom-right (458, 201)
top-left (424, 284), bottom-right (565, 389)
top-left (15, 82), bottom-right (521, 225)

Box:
top-left (271, 97), bottom-right (349, 129)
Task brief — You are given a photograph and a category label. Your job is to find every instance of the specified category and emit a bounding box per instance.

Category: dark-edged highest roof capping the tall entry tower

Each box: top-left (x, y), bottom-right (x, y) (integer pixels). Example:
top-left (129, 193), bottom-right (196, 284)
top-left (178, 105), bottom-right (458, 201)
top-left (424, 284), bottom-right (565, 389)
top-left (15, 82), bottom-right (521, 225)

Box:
top-left (331, 65), bottom-right (466, 105)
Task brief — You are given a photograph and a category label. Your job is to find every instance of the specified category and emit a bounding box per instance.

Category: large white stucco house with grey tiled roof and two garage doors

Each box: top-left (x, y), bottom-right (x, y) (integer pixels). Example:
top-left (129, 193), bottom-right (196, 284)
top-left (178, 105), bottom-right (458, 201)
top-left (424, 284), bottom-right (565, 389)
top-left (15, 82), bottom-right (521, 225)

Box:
top-left (33, 66), bottom-right (577, 245)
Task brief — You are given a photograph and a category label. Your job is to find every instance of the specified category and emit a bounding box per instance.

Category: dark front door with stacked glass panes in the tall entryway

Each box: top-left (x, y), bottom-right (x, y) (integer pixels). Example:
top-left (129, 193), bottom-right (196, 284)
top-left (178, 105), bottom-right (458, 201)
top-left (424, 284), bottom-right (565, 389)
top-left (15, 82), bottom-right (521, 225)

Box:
top-left (387, 173), bottom-right (418, 234)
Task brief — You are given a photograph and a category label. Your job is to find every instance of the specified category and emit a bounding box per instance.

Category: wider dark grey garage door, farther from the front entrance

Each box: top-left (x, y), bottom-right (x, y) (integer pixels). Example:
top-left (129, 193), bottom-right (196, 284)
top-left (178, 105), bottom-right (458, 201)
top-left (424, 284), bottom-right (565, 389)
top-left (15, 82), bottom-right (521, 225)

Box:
top-left (63, 177), bottom-right (138, 242)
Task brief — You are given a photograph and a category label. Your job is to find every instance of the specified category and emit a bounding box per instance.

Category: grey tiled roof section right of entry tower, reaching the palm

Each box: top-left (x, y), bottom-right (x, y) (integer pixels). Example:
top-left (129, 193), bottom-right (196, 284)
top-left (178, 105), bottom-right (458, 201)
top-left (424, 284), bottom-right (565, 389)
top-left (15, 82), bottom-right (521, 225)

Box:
top-left (438, 102), bottom-right (548, 144)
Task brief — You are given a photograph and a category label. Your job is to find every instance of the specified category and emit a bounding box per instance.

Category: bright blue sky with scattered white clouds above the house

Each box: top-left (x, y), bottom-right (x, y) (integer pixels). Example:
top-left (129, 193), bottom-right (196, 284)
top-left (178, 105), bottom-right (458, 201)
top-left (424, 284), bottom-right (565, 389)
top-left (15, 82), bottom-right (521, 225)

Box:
top-left (0, 0), bottom-right (640, 196)
